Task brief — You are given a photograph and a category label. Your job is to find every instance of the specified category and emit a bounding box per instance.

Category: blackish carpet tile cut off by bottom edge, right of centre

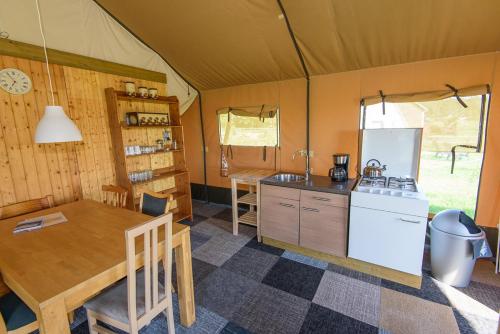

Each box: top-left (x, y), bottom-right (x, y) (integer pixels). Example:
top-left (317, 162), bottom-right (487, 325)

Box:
top-left (300, 303), bottom-right (378, 334)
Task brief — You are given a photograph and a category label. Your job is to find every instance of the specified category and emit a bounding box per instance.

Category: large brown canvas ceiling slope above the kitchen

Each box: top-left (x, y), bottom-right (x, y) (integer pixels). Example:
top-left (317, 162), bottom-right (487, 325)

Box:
top-left (96, 0), bottom-right (500, 89)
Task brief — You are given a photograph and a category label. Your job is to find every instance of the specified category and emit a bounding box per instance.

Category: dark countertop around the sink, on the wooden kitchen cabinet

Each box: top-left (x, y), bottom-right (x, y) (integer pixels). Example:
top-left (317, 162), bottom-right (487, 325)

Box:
top-left (260, 175), bottom-right (356, 196)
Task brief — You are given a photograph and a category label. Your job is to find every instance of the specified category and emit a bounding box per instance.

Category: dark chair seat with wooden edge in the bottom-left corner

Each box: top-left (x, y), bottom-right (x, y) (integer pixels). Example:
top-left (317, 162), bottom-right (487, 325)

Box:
top-left (0, 292), bottom-right (38, 334)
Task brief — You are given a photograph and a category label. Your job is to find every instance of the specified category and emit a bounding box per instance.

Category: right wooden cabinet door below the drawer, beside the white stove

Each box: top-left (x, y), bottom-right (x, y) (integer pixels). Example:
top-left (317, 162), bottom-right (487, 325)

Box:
top-left (300, 202), bottom-right (347, 257)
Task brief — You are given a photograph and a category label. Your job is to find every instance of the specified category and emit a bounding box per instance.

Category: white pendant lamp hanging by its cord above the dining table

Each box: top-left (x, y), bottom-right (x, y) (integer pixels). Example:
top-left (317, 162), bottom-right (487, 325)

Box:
top-left (35, 0), bottom-right (82, 144)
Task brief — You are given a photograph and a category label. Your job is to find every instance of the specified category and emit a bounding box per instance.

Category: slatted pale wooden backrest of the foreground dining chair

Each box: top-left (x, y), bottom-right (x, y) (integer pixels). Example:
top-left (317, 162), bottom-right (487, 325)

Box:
top-left (125, 213), bottom-right (172, 333)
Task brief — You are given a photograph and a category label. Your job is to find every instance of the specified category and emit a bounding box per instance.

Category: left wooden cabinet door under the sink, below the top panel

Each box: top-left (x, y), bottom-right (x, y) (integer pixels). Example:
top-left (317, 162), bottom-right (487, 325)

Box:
top-left (260, 196), bottom-right (299, 245)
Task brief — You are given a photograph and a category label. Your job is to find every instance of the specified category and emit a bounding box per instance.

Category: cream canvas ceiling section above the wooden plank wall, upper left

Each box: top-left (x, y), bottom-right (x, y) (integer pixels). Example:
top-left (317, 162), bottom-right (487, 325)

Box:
top-left (0, 0), bottom-right (197, 111)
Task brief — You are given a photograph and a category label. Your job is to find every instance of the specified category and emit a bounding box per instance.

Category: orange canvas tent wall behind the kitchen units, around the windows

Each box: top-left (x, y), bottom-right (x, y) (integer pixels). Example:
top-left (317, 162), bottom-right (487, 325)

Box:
top-left (182, 53), bottom-right (500, 226)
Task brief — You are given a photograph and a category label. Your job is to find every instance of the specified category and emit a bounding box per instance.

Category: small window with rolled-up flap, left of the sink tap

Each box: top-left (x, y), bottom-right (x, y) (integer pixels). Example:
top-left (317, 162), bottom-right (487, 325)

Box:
top-left (217, 106), bottom-right (279, 146)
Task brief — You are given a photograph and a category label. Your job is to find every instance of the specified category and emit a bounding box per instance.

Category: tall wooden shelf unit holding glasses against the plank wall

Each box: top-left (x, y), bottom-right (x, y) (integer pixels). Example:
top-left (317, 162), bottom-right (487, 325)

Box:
top-left (105, 88), bottom-right (193, 222)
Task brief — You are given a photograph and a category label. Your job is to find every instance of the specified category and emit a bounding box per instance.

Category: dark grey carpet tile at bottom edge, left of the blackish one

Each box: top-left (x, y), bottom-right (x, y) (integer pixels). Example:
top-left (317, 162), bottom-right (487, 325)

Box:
top-left (233, 284), bottom-right (310, 334)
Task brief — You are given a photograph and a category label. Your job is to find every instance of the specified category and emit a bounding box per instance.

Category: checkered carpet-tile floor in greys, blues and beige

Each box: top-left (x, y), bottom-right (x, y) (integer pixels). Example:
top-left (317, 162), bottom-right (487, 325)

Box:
top-left (72, 201), bottom-right (500, 334)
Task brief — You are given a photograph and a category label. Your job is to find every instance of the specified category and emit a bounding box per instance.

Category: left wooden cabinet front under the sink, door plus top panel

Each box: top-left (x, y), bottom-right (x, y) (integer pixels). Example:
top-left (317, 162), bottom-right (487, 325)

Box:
top-left (260, 185), bottom-right (300, 245)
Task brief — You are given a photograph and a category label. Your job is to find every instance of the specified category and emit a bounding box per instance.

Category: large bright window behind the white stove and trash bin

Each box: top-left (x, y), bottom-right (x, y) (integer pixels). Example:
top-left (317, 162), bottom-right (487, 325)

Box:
top-left (361, 95), bottom-right (487, 218)
